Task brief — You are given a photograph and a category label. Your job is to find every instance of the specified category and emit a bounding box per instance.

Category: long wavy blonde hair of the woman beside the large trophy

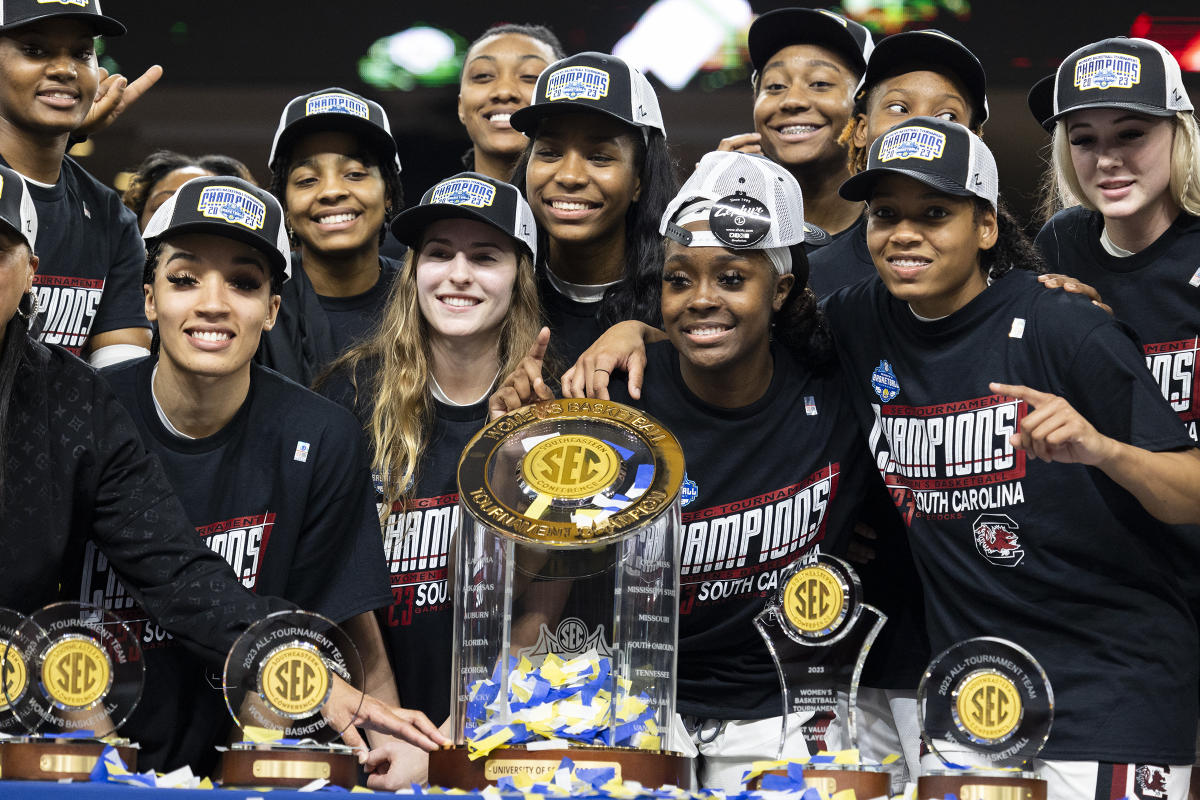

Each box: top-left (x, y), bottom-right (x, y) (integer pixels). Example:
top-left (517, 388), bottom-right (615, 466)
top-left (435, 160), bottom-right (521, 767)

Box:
top-left (325, 241), bottom-right (541, 516)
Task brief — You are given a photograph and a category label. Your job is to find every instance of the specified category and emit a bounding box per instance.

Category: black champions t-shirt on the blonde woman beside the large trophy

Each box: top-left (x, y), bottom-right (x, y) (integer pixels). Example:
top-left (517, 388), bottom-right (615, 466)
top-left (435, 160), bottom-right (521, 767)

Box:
top-left (323, 371), bottom-right (487, 724)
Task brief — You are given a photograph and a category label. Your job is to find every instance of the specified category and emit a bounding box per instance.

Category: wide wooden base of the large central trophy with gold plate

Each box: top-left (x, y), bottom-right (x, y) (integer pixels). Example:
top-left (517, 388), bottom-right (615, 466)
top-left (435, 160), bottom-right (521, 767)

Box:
top-left (430, 745), bottom-right (691, 792)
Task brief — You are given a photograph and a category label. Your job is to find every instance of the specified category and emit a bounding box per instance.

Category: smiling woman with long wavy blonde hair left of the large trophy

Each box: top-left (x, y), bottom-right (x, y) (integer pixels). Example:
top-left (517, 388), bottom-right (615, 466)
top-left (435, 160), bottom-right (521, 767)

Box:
top-left (320, 173), bottom-right (540, 788)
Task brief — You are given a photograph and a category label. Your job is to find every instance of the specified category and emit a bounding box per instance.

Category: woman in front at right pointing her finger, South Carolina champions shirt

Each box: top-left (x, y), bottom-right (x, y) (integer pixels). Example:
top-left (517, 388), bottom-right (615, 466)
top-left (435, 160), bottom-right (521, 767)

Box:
top-left (826, 116), bottom-right (1200, 800)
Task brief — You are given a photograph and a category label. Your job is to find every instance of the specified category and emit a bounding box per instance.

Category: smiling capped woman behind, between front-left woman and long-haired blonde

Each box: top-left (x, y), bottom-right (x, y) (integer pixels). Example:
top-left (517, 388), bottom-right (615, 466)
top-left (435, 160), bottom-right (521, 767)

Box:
top-left (257, 88), bottom-right (403, 386)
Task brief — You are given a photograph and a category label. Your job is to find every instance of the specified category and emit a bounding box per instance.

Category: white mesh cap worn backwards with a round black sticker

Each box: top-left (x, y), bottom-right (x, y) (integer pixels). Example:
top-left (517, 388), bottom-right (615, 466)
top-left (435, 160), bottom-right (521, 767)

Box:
top-left (659, 151), bottom-right (826, 273)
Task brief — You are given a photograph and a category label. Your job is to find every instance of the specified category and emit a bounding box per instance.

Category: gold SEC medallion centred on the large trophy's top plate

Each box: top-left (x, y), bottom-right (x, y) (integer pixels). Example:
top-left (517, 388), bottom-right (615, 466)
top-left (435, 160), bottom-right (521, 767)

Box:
top-left (521, 434), bottom-right (620, 500)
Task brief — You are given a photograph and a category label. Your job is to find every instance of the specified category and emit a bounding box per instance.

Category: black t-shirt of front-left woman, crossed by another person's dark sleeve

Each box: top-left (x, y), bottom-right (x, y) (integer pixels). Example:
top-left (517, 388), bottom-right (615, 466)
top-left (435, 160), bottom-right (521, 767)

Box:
top-left (99, 357), bottom-right (390, 774)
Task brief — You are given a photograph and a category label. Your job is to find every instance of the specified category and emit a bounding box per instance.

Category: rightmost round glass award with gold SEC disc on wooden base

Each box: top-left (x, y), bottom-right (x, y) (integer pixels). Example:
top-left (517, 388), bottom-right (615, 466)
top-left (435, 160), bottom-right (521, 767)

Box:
top-left (917, 637), bottom-right (1054, 800)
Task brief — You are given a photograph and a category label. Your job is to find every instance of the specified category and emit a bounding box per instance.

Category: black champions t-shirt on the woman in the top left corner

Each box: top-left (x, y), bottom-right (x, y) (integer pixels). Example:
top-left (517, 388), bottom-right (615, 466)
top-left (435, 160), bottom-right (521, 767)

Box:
top-left (0, 156), bottom-right (150, 355)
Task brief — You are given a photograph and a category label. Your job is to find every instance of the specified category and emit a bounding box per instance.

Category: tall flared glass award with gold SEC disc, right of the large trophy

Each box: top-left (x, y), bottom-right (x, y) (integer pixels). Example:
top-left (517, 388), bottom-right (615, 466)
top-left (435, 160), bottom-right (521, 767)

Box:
top-left (755, 554), bottom-right (890, 798)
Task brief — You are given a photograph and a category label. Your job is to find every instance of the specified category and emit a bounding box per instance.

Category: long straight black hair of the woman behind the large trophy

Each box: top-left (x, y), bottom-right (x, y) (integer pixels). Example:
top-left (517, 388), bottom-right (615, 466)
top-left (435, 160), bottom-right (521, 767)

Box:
top-left (512, 126), bottom-right (679, 327)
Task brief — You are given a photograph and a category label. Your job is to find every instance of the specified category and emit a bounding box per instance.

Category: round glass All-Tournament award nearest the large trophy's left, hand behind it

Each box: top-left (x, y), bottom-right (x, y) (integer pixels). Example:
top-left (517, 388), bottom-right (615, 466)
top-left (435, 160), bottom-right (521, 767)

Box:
top-left (221, 612), bottom-right (364, 788)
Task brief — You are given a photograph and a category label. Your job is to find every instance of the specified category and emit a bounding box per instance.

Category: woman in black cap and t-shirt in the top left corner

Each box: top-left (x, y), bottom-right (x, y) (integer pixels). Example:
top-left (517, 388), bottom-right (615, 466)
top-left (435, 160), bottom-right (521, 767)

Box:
top-left (0, 4), bottom-right (150, 366)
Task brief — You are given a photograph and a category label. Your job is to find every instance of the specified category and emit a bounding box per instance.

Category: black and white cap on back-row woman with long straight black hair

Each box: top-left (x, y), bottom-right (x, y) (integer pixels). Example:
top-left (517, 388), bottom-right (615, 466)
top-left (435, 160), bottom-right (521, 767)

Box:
top-left (509, 53), bottom-right (667, 138)
